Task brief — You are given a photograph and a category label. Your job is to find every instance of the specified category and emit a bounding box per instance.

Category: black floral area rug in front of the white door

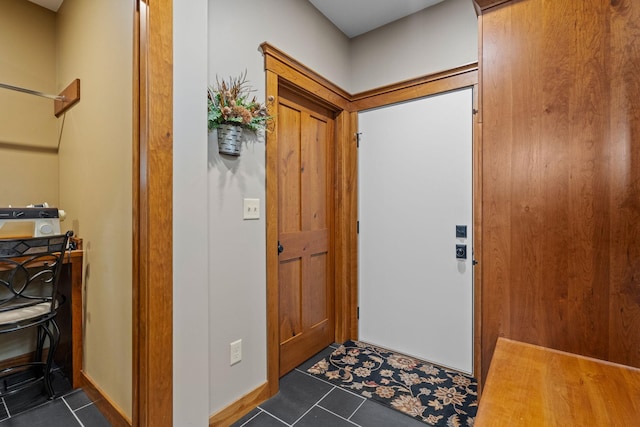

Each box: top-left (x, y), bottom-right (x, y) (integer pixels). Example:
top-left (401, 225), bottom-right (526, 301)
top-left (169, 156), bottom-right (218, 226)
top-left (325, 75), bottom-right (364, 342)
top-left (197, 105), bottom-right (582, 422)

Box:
top-left (307, 341), bottom-right (478, 427)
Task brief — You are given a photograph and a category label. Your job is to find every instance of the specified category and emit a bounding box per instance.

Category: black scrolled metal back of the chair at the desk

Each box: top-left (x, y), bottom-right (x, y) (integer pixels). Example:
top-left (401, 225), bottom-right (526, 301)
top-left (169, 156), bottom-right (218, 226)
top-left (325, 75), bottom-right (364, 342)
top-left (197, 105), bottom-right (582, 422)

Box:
top-left (0, 231), bottom-right (73, 322)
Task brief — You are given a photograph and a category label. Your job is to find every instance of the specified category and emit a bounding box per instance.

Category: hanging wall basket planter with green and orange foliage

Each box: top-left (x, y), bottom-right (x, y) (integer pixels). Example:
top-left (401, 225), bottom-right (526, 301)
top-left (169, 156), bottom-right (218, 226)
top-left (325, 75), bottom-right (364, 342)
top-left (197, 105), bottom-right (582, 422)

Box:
top-left (207, 71), bottom-right (273, 156)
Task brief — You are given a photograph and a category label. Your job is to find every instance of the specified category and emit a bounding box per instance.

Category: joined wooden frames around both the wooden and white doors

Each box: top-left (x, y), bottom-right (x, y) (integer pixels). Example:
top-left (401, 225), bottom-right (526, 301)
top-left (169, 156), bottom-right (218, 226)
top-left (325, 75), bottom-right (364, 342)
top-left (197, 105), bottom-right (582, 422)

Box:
top-left (260, 43), bottom-right (482, 398)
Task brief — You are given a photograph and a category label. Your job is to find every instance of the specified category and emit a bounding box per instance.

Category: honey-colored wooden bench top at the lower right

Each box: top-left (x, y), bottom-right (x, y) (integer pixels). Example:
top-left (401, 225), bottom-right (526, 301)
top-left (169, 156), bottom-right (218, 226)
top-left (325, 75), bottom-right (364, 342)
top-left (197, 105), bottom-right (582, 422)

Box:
top-left (475, 338), bottom-right (640, 427)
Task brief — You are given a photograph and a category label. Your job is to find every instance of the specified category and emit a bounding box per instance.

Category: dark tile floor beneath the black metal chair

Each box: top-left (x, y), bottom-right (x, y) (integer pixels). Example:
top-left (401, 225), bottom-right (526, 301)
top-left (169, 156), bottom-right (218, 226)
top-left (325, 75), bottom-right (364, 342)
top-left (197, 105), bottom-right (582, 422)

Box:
top-left (0, 370), bottom-right (111, 427)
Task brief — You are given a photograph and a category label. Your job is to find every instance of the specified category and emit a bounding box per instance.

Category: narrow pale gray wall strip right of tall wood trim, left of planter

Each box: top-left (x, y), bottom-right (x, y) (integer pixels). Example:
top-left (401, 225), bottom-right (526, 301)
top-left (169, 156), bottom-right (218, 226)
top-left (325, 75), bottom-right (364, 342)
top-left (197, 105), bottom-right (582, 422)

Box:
top-left (173, 0), bottom-right (209, 427)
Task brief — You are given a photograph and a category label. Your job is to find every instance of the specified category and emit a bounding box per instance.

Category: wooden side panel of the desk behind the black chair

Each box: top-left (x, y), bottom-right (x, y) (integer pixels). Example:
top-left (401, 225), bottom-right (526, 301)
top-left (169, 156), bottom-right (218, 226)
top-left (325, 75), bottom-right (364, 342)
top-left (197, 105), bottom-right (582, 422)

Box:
top-left (54, 250), bottom-right (82, 388)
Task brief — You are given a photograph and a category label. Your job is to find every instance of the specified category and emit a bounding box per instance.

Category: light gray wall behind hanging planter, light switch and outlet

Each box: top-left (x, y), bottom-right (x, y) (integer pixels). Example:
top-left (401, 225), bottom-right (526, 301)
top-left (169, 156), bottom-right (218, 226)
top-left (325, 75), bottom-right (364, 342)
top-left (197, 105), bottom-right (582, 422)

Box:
top-left (208, 0), bottom-right (349, 413)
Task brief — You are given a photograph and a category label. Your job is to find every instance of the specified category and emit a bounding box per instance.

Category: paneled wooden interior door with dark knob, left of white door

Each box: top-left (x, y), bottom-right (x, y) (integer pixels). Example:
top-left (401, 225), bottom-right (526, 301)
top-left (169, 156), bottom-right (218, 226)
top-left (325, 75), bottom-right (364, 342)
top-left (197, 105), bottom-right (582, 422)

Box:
top-left (277, 88), bottom-right (334, 376)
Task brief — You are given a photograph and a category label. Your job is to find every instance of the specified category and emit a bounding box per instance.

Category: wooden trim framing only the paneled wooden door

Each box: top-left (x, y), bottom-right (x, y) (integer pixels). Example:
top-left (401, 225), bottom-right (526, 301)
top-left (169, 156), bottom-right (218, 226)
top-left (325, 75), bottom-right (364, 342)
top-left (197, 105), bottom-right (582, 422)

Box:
top-left (260, 43), bottom-right (357, 396)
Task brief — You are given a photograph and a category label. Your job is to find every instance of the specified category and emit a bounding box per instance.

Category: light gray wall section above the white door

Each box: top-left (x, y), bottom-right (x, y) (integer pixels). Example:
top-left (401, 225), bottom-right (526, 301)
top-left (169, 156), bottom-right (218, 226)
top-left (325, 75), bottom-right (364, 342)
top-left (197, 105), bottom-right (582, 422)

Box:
top-left (350, 0), bottom-right (478, 93)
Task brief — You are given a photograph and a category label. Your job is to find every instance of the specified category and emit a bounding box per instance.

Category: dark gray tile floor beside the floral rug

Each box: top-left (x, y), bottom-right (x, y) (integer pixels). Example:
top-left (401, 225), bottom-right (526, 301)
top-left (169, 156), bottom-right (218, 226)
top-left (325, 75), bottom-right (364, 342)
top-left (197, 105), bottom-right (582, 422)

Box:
top-left (232, 347), bottom-right (425, 427)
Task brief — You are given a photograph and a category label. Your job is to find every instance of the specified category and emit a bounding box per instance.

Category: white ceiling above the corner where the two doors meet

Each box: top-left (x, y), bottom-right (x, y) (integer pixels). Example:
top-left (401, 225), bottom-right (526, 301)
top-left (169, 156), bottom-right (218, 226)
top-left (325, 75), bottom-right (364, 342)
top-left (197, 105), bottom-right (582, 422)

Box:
top-left (309, 0), bottom-right (444, 38)
